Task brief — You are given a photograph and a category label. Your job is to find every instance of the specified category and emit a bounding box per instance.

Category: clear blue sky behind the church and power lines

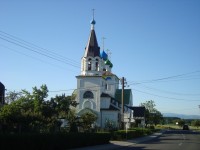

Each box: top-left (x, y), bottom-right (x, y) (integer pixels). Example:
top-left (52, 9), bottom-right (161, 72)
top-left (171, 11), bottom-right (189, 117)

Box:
top-left (0, 0), bottom-right (200, 115)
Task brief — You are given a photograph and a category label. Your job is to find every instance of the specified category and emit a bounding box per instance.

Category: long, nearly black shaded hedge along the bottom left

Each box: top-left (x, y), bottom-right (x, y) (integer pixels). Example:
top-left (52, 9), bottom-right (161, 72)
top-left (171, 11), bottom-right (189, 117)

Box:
top-left (0, 133), bottom-right (111, 150)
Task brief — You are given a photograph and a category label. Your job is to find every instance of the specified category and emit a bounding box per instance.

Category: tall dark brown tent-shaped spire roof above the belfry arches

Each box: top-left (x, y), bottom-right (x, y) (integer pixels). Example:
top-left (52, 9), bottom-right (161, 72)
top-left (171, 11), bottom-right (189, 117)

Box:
top-left (84, 29), bottom-right (100, 57)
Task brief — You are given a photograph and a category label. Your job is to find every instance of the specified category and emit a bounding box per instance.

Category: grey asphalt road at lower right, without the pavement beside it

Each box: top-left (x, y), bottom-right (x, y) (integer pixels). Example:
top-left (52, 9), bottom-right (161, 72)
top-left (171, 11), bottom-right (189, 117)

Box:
top-left (120, 130), bottom-right (200, 150)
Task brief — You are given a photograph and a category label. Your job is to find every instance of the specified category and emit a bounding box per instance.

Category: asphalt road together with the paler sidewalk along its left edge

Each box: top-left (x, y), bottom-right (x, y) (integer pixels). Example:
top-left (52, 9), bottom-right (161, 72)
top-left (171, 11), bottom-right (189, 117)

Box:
top-left (73, 130), bottom-right (200, 150)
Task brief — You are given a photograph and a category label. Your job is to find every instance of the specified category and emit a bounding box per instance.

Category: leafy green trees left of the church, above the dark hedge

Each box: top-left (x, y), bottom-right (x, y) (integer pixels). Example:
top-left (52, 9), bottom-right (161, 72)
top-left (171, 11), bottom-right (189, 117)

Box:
top-left (0, 85), bottom-right (97, 133)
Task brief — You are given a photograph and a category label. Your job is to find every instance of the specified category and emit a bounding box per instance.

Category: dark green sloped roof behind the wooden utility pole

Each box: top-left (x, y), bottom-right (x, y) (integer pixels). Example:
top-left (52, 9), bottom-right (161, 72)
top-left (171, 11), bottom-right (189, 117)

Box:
top-left (115, 89), bottom-right (132, 105)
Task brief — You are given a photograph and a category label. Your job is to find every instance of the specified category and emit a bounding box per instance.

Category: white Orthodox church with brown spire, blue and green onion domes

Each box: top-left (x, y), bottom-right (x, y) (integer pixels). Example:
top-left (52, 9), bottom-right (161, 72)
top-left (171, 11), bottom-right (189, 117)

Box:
top-left (72, 14), bottom-right (133, 128)
